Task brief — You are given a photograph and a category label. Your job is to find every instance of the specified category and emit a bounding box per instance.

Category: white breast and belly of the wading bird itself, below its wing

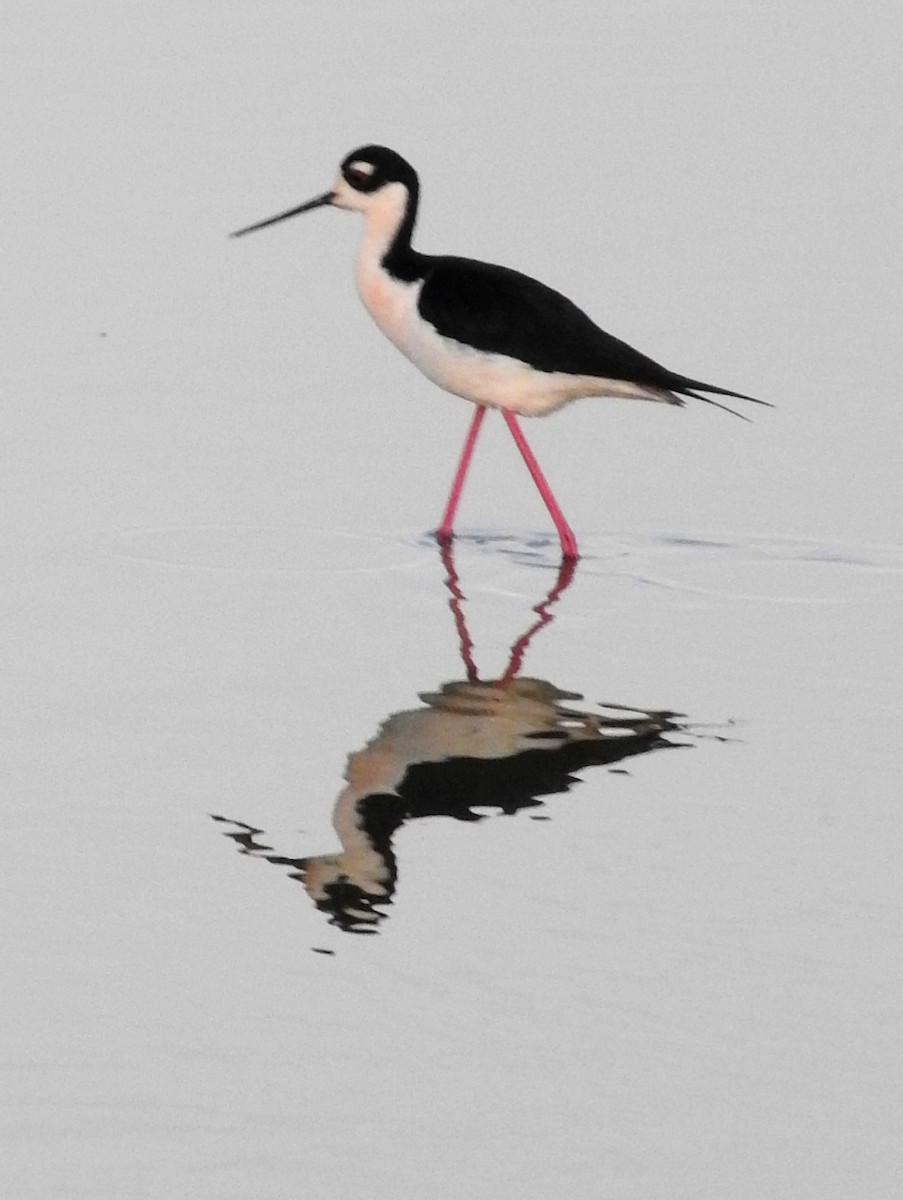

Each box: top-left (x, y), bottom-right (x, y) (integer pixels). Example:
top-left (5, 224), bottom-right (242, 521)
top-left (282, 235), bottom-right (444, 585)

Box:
top-left (357, 259), bottom-right (674, 416)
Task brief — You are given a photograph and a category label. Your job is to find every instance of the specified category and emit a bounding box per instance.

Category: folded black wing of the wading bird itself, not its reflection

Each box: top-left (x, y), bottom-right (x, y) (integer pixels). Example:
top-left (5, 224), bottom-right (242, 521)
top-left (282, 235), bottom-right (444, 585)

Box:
top-left (418, 257), bottom-right (765, 403)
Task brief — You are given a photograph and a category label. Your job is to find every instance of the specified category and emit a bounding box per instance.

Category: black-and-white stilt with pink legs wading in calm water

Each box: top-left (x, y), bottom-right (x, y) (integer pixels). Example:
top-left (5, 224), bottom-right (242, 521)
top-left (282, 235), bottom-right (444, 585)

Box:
top-left (232, 145), bottom-right (766, 558)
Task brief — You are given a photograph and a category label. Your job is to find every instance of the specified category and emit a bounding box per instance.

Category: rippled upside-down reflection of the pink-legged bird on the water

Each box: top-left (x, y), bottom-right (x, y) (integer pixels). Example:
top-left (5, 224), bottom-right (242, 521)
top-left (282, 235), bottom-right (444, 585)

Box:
top-left (214, 544), bottom-right (682, 932)
